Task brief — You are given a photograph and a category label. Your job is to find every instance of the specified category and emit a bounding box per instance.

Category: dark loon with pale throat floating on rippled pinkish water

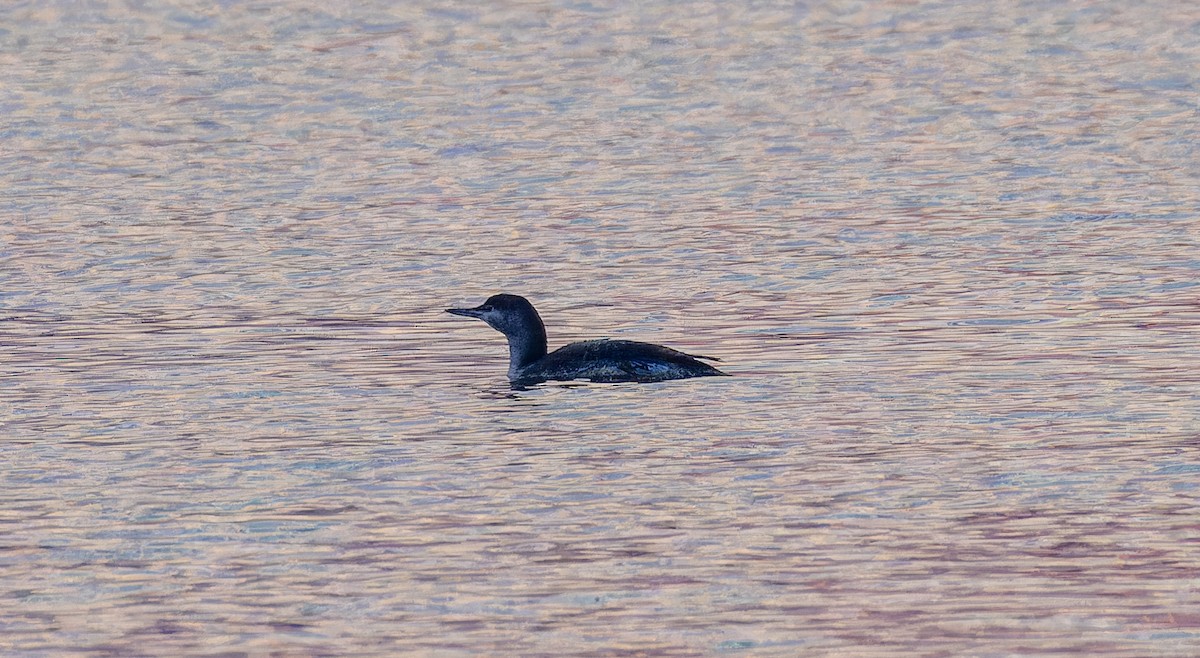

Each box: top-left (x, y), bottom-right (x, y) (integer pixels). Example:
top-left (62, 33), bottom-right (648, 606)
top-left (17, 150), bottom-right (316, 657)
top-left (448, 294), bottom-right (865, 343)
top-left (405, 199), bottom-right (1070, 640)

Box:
top-left (446, 294), bottom-right (727, 385)
